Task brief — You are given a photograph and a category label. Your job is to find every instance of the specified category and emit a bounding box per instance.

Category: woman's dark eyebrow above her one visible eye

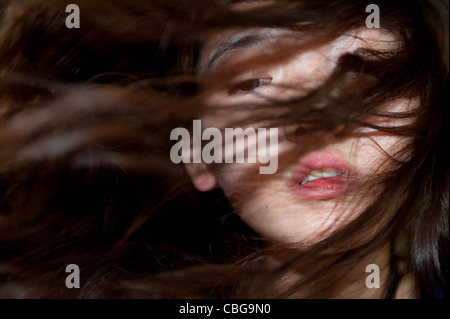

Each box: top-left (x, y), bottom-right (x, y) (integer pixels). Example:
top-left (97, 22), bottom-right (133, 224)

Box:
top-left (207, 34), bottom-right (274, 69)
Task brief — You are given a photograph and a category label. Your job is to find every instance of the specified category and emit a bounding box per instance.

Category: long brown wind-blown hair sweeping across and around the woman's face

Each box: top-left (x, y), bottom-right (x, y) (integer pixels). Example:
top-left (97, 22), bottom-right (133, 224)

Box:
top-left (0, 0), bottom-right (450, 298)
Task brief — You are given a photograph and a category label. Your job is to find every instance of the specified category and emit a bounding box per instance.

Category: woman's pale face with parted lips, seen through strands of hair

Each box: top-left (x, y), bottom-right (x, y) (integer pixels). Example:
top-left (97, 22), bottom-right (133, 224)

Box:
top-left (187, 29), bottom-right (412, 245)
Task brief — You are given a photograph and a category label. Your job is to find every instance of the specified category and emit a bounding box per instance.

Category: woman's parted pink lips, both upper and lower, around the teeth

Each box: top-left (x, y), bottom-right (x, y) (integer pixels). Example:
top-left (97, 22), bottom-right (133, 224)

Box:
top-left (291, 150), bottom-right (358, 200)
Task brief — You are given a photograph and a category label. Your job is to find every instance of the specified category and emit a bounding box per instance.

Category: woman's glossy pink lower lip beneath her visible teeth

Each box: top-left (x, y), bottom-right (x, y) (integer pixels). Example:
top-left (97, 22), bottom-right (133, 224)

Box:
top-left (291, 176), bottom-right (354, 200)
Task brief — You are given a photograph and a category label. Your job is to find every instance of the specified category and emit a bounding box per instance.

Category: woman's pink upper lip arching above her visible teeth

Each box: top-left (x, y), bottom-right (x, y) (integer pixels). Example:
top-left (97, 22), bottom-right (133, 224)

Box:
top-left (292, 150), bottom-right (356, 185)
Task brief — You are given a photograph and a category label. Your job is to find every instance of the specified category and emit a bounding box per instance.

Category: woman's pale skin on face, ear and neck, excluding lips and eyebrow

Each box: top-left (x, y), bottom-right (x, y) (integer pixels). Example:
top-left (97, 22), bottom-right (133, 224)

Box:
top-left (185, 28), bottom-right (416, 298)
